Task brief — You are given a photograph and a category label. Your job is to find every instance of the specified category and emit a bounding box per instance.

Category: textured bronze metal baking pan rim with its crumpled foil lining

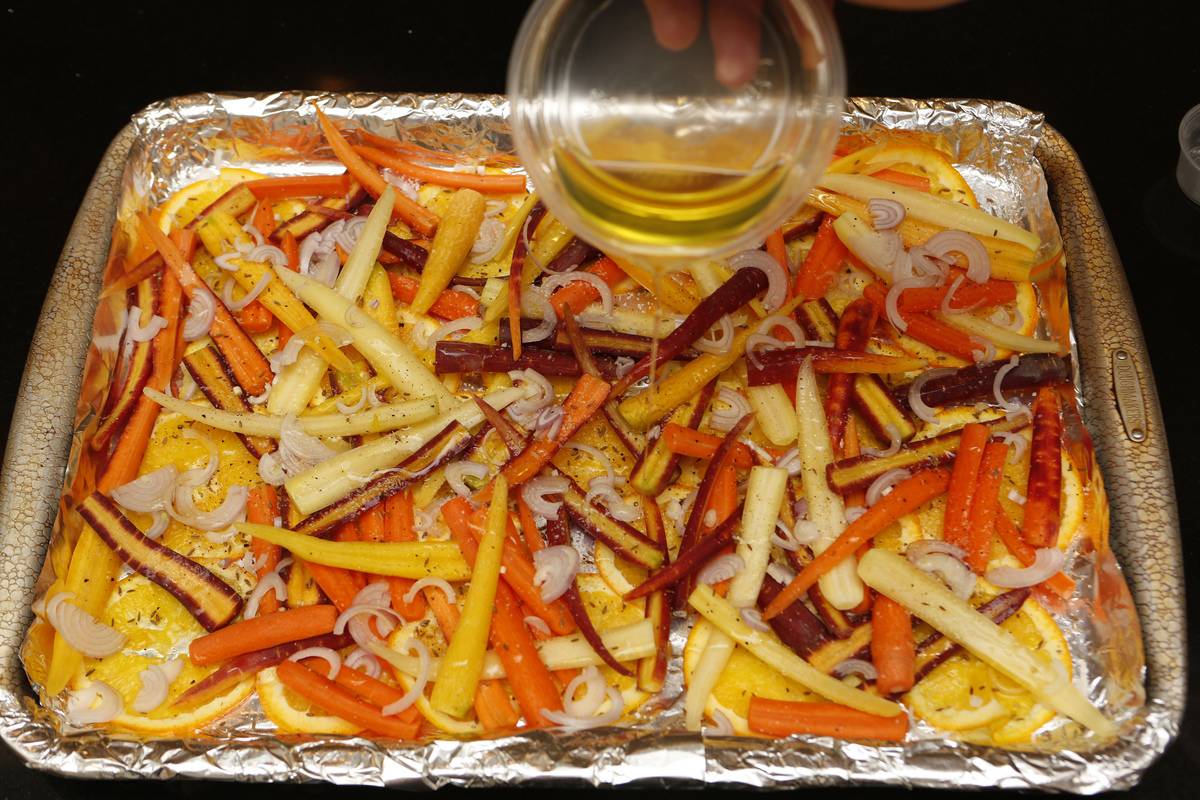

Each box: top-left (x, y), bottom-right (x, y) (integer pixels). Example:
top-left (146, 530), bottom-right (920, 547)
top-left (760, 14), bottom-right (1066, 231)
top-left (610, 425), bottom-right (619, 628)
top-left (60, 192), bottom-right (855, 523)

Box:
top-left (0, 92), bottom-right (1186, 794)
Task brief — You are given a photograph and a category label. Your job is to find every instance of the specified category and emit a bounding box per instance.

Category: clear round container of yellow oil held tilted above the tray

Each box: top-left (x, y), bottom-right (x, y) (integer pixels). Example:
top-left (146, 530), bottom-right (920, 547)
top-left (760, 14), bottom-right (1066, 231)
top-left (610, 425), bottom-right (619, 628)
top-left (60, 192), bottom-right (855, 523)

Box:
top-left (508, 0), bottom-right (846, 265)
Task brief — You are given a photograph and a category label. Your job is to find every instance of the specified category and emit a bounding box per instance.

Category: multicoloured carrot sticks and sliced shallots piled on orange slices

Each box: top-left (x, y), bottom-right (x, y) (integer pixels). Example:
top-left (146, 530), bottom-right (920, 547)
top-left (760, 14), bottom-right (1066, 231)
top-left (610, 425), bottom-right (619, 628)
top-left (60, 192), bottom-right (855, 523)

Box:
top-left (24, 117), bottom-right (1115, 746)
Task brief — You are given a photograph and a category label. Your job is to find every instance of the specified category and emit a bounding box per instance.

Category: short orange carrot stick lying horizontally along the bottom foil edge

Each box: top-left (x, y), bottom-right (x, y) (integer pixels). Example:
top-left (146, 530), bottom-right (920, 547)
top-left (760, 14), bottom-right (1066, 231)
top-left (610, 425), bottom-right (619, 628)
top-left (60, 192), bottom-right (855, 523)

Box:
top-left (748, 696), bottom-right (908, 741)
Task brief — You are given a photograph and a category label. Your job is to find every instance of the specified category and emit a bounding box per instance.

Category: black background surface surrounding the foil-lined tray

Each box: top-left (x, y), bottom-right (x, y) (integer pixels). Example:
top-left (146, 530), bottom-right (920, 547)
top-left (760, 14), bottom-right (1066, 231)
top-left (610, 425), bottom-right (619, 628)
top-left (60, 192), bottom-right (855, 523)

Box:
top-left (0, 0), bottom-right (1200, 800)
